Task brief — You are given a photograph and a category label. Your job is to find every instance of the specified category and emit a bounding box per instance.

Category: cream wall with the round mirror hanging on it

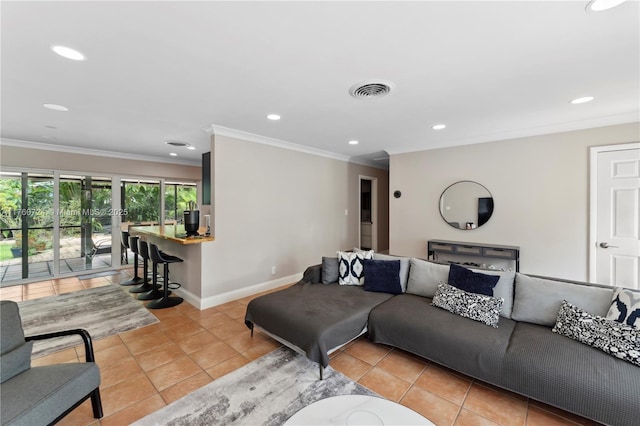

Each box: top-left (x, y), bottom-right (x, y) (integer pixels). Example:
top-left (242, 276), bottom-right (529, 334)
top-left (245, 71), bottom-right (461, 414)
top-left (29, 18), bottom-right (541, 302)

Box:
top-left (389, 123), bottom-right (640, 281)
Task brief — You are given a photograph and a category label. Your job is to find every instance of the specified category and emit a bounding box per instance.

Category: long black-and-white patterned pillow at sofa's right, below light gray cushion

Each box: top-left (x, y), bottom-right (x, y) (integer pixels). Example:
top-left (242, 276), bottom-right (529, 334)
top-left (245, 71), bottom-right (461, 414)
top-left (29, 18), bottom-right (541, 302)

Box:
top-left (553, 300), bottom-right (640, 366)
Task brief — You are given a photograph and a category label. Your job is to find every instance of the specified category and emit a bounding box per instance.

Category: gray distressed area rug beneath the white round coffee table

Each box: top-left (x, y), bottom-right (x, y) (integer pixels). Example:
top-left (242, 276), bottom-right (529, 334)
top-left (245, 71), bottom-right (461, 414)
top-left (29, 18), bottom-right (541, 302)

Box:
top-left (133, 347), bottom-right (377, 426)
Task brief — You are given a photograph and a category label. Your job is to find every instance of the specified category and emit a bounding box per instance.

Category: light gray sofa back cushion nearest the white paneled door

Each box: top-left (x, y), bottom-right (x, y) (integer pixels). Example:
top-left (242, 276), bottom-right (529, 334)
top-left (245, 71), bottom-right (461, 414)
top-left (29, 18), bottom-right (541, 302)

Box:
top-left (511, 272), bottom-right (613, 327)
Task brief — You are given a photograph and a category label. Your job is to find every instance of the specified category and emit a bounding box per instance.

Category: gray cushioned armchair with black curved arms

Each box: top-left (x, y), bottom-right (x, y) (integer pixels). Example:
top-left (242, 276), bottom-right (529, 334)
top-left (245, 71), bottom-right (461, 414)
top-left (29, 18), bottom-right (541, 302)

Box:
top-left (0, 301), bottom-right (103, 425)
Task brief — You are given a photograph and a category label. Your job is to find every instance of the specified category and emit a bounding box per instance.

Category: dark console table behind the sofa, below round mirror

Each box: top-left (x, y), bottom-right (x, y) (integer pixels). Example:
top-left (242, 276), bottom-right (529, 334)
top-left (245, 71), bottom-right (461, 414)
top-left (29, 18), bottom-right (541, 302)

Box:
top-left (427, 240), bottom-right (520, 272)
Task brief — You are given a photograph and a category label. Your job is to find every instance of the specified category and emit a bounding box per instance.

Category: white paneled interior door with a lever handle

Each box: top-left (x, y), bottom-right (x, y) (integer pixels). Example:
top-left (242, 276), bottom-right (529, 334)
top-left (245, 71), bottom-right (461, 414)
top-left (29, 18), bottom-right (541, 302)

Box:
top-left (589, 143), bottom-right (640, 288)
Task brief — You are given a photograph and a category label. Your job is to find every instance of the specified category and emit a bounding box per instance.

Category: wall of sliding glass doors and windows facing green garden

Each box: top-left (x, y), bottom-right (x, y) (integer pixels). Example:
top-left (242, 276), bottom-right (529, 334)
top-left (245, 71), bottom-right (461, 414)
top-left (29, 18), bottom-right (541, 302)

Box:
top-left (0, 169), bottom-right (197, 285)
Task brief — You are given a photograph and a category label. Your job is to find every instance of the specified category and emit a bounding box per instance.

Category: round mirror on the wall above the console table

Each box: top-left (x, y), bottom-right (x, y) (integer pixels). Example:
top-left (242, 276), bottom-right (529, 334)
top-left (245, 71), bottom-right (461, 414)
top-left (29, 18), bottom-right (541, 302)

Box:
top-left (440, 180), bottom-right (493, 229)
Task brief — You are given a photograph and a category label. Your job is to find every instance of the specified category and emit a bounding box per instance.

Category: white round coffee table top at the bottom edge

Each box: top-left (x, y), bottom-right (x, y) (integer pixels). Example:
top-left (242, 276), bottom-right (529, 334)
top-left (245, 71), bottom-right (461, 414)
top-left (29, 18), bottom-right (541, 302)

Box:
top-left (285, 395), bottom-right (434, 426)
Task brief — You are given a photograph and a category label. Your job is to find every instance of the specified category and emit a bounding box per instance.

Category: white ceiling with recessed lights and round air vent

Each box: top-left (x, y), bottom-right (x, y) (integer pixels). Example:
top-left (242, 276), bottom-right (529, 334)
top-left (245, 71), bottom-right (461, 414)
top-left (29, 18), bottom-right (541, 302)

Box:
top-left (0, 1), bottom-right (640, 165)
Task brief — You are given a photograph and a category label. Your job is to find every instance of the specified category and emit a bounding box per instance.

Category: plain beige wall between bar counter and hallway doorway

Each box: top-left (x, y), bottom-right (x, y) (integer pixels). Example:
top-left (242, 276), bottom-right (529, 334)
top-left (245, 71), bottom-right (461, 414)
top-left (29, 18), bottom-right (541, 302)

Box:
top-left (201, 136), bottom-right (388, 298)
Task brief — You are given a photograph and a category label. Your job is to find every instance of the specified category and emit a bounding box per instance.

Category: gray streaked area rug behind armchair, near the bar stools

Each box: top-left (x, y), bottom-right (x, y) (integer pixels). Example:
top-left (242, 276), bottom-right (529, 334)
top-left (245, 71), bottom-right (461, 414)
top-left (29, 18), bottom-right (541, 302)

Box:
top-left (18, 285), bottom-right (158, 358)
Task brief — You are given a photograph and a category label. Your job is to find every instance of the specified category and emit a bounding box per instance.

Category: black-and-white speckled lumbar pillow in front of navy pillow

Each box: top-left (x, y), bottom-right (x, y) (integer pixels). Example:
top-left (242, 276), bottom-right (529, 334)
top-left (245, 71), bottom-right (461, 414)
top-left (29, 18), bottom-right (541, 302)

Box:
top-left (431, 282), bottom-right (504, 328)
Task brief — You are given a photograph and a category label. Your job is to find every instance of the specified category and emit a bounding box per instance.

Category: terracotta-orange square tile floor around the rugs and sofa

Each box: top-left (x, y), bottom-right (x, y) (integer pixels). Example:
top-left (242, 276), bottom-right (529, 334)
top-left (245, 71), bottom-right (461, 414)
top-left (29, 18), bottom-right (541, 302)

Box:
top-left (0, 271), bottom-right (595, 426)
